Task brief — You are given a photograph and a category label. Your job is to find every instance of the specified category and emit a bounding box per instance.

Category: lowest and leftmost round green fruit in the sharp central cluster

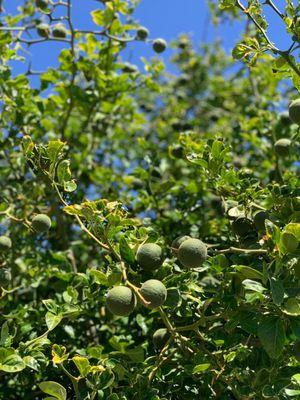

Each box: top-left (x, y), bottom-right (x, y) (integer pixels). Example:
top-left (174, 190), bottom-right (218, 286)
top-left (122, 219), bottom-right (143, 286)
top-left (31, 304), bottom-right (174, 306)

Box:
top-left (106, 286), bottom-right (136, 317)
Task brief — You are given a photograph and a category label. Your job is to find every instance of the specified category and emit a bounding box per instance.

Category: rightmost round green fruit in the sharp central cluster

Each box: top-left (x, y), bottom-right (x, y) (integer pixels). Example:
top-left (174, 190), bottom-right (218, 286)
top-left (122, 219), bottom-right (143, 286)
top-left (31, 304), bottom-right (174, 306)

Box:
top-left (178, 238), bottom-right (207, 268)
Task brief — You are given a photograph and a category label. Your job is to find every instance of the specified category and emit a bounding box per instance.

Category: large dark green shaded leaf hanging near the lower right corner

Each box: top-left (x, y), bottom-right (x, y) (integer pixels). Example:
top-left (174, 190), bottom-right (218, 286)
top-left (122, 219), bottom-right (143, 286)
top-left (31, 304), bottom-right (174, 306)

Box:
top-left (258, 316), bottom-right (285, 358)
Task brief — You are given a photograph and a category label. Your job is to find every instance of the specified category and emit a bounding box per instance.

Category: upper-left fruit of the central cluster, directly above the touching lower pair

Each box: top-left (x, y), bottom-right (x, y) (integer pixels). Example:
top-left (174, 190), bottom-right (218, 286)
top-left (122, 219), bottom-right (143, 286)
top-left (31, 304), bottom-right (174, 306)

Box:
top-left (136, 243), bottom-right (163, 271)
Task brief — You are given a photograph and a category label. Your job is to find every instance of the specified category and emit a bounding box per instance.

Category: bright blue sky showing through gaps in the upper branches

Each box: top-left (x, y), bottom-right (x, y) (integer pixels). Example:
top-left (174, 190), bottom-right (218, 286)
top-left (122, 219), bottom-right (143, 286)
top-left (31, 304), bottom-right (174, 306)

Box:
top-left (4, 0), bottom-right (289, 77)
